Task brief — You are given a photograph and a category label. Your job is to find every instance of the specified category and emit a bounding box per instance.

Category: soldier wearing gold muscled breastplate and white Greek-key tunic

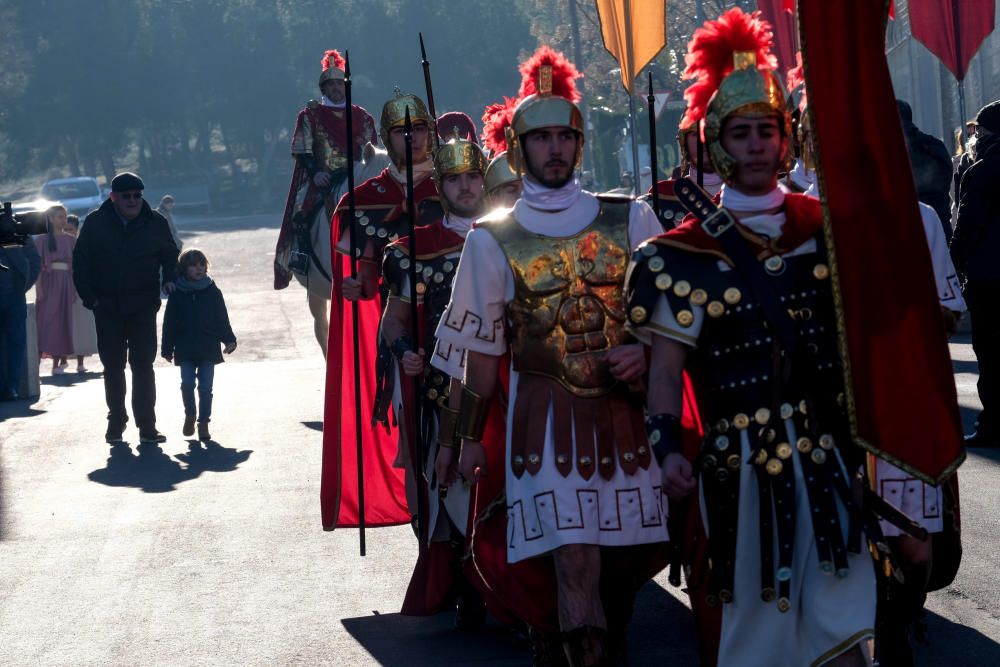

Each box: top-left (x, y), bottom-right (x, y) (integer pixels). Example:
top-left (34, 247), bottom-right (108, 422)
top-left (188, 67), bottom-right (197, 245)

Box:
top-left (437, 47), bottom-right (667, 665)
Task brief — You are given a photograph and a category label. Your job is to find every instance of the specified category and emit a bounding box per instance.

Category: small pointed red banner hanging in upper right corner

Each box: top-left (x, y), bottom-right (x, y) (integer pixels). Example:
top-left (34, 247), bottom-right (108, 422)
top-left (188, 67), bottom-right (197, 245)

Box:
top-left (910, 0), bottom-right (996, 81)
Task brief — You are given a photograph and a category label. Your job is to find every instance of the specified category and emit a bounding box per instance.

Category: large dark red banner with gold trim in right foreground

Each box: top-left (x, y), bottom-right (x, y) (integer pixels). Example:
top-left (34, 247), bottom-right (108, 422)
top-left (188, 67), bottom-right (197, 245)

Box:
top-left (798, 0), bottom-right (965, 483)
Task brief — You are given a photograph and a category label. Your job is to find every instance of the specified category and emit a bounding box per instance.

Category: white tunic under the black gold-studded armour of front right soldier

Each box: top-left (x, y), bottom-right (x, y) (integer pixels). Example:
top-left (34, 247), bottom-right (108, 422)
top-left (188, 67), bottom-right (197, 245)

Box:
top-left (635, 190), bottom-right (875, 667)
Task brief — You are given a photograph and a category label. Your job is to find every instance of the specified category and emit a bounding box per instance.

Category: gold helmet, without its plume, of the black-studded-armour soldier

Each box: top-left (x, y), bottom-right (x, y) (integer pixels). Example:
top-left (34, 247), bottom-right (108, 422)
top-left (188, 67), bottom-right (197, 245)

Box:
top-left (705, 51), bottom-right (792, 181)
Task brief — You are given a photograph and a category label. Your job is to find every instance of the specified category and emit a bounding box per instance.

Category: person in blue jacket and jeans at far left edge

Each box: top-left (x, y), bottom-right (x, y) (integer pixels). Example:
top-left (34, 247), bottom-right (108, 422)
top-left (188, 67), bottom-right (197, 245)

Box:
top-left (0, 232), bottom-right (41, 401)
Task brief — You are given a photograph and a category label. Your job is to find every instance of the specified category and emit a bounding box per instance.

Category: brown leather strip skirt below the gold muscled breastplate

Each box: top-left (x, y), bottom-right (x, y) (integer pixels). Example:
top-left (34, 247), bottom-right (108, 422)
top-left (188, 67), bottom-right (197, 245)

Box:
top-left (510, 373), bottom-right (652, 480)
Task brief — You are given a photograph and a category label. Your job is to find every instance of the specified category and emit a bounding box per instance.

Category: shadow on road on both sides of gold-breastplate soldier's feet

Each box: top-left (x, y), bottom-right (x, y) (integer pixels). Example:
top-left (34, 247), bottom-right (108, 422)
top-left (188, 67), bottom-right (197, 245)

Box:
top-left (341, 582), bottom-right (698, 667)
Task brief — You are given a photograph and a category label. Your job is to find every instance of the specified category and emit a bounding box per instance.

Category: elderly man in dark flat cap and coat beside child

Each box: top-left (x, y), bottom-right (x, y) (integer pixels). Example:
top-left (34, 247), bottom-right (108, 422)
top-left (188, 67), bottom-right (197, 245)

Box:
top-left (73, 172), bottom-right (177, 444)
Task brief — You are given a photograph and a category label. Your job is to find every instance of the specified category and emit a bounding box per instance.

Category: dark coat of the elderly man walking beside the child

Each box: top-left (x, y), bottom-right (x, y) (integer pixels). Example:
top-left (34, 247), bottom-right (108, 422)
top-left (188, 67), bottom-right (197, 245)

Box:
top-left (73, 199), bottom-right (177, 315)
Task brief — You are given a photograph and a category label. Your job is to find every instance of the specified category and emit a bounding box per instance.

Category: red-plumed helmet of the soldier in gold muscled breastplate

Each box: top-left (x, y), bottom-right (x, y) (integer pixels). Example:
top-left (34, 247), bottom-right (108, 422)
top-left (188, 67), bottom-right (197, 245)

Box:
top-left (506, 46), bottom-right (583, 176)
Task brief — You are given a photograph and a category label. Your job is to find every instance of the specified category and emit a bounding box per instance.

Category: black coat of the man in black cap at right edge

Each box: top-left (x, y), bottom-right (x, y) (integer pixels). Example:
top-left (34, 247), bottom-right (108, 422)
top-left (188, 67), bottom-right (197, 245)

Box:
top-left (951, 135), bottom-right (1000, 282)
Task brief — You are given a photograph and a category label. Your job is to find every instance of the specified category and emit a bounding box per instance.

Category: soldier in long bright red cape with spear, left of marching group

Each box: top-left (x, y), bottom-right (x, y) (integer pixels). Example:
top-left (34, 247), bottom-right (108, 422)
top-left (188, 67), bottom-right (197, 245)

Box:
top-left (320, 88), bottom-right (442, 529)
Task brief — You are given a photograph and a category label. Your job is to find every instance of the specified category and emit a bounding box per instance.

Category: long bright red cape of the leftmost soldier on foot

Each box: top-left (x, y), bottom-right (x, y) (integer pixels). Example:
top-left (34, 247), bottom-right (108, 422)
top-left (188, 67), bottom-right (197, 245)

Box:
top-left (320, 169), bottom-right (437, 530)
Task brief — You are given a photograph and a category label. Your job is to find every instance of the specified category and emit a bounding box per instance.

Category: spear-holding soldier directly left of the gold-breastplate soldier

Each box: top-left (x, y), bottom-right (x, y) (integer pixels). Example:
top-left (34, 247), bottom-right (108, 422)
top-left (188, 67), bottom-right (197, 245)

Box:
top-left (382, 129), bottom-right (486, 628)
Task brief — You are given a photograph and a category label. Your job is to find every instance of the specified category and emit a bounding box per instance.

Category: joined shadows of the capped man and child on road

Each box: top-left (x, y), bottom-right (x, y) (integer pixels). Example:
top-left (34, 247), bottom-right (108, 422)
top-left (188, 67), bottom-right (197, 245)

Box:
top-left (87, 441), bottom-right (252, 493)
